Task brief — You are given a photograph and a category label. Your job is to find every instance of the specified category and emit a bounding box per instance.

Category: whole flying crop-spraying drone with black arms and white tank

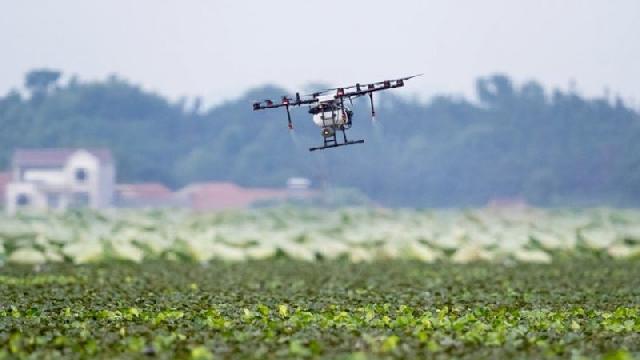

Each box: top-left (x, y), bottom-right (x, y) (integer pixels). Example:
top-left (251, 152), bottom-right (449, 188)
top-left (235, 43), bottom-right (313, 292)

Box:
top-left (253, 74), bottom-right (422, 151)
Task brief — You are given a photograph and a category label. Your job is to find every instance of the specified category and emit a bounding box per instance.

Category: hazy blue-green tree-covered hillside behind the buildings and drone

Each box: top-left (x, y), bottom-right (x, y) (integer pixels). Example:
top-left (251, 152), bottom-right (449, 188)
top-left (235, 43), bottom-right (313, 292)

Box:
top-left (0, 70), bottom-right (640, 207)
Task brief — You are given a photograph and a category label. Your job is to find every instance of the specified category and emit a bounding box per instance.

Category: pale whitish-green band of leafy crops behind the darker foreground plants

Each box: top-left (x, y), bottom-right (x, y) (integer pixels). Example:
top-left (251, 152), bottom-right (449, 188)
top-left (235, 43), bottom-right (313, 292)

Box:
top-left (0, 207), bottom-right (640, 264)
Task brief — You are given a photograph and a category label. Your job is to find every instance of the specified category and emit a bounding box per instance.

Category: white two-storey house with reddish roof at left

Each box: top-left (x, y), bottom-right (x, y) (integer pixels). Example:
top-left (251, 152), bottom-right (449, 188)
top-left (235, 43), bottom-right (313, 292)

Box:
top-left (5, 149), bottom-right (115, 214)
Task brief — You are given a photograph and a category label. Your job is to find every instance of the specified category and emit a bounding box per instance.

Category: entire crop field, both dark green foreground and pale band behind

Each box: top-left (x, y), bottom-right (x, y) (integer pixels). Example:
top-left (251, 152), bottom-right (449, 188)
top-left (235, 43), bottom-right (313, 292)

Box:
top-left (0, 208), bottom-right (640, 359)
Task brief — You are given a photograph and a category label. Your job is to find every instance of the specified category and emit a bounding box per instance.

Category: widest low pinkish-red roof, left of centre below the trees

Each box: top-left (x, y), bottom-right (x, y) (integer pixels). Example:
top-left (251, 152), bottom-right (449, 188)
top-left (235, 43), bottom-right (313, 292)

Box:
top-left (180, 183), bottom-right (287, 210)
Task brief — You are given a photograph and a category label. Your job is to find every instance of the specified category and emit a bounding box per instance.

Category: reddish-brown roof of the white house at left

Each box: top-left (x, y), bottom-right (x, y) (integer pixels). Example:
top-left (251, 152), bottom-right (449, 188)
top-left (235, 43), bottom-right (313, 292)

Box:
top-left (12, 148), bottom-right (113, 166)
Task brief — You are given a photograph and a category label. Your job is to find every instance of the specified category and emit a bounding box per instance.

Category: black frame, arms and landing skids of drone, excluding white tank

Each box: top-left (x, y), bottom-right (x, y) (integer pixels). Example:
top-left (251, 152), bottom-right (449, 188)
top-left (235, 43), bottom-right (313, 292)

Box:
top-left (253, 74), bottom-right (422, 151)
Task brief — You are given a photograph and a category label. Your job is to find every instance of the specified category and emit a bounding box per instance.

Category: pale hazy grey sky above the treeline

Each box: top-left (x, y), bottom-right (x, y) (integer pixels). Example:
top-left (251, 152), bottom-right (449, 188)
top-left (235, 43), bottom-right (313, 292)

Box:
top-left (0, 0), bottom-right (640, 105)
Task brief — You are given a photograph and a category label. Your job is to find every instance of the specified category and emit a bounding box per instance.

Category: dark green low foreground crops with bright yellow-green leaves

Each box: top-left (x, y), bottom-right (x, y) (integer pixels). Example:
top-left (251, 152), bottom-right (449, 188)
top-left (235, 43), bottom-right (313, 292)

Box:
top-left (0, 258), bottom-right (640, 359)
